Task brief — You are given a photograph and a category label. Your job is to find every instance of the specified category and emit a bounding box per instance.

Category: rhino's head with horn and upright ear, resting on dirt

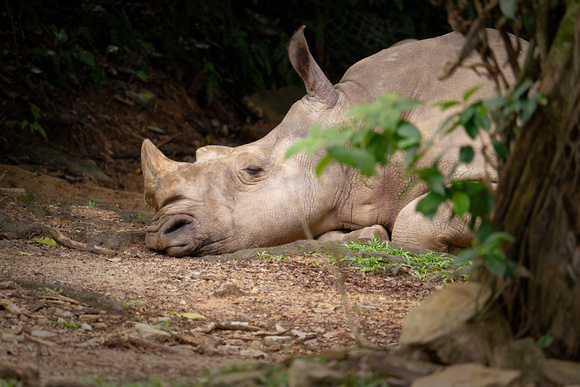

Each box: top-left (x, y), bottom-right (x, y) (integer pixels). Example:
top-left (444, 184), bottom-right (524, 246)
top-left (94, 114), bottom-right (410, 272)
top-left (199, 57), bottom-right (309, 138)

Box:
top-left (141, 27), bottom-right (348, 256)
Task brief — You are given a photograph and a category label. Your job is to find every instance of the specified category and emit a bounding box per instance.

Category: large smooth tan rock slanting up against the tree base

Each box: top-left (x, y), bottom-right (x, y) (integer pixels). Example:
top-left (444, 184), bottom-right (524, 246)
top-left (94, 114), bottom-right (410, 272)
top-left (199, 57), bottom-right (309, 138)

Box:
top-left (400, 282), bottom-right (491, 345)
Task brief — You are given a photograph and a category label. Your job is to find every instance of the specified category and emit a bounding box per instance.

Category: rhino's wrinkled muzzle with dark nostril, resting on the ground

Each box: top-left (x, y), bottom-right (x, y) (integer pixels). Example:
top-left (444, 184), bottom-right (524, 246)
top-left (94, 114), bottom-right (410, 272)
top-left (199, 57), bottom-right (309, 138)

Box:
top-left (145, 214), bottom-right (197, 257)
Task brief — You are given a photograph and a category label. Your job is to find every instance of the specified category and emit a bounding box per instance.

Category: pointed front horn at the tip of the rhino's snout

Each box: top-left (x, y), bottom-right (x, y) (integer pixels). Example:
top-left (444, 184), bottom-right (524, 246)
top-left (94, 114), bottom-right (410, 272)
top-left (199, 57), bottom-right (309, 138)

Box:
top-left (141, 139), bottom-right (176, 210)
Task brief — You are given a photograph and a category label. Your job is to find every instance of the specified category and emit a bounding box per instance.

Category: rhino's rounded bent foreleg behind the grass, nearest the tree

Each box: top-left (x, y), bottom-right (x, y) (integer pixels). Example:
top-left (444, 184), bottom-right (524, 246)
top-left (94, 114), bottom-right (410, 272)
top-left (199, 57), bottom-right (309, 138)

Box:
top-left (392, 195), bottom-right (475, 254)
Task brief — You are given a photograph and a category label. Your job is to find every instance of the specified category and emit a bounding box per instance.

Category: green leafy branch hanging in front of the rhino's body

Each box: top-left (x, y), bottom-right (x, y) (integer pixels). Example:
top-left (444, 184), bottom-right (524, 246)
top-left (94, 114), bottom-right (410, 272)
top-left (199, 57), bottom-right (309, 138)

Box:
top-left (286, 82), bottom-right (545, 276)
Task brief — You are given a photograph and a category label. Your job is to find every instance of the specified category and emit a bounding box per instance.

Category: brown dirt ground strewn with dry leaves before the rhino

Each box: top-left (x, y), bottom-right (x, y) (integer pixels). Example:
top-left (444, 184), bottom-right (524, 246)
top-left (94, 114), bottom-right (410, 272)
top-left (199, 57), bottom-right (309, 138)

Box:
top-left (0, 165), bottom-right (436, 385)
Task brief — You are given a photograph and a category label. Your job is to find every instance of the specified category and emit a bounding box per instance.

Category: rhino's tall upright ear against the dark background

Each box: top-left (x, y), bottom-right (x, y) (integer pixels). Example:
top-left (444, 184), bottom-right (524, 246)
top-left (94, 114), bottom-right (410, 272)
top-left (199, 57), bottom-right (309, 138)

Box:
top-left (288, 26), bottom-right (338, 106)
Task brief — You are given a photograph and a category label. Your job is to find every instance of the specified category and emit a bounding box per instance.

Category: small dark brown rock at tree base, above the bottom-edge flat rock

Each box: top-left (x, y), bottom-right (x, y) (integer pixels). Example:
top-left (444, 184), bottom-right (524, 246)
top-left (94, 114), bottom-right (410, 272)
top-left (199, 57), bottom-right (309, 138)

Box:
top-left (491, 337), bottom-right (545, 379)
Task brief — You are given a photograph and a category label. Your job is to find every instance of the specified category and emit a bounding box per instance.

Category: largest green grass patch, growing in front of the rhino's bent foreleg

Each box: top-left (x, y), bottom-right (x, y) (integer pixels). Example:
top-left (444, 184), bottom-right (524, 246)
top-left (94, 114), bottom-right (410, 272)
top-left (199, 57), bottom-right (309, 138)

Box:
top-left (342, 237), bottom-right (471, 284)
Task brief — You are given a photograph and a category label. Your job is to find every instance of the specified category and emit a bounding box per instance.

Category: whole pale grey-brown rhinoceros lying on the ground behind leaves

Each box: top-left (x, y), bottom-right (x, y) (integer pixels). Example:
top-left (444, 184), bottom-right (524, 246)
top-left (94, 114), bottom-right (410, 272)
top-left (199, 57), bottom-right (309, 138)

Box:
top-left (141, 27), bottom-right (527, 257)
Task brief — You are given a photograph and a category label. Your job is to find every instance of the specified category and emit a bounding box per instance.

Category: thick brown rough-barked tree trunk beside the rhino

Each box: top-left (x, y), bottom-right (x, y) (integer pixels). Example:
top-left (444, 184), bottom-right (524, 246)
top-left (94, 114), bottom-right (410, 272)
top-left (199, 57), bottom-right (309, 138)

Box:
top-left (489, 1), bottom-right (580, 361)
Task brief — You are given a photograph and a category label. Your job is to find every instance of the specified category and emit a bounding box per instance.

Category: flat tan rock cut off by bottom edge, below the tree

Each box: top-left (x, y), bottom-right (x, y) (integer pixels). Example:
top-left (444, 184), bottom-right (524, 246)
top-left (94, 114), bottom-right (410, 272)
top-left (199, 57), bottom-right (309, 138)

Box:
top-left (411, 363), bottom-right (521, 387)
